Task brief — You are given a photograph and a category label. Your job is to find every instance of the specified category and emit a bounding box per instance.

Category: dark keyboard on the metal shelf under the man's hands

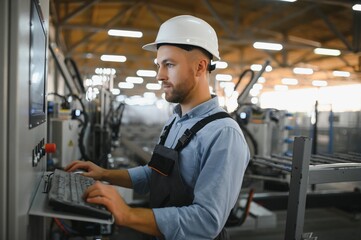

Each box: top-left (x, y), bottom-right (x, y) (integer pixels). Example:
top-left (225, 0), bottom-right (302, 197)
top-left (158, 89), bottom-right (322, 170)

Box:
top-left (48, 169), bottom-right (112, 219)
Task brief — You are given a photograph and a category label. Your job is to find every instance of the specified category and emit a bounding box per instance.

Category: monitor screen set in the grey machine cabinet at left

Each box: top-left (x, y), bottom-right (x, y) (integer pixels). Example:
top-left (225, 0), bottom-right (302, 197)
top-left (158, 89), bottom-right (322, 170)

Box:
top-left (29, 0), bottom-right (47, 128)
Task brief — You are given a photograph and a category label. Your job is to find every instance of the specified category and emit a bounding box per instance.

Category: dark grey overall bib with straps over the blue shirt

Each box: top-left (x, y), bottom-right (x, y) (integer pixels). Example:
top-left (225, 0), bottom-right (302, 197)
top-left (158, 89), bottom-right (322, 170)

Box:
top-left (148, 112), bottom-right (230, 240)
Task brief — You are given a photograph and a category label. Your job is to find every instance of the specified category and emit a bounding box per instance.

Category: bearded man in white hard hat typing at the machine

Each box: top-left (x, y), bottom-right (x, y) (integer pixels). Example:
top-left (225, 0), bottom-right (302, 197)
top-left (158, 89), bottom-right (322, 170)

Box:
top-left (66, 15), bottom-right (249, 240)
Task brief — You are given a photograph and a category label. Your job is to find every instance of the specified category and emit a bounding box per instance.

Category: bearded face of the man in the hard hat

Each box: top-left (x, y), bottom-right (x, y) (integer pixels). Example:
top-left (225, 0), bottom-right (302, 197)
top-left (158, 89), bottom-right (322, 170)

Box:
top-left (157, 45), bottom-right (196, 104)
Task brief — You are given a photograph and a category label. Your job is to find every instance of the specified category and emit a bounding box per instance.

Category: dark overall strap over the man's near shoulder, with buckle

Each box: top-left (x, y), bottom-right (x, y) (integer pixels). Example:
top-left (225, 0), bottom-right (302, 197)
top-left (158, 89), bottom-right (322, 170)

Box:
top-left (174, 112), bottom-right (231, 151)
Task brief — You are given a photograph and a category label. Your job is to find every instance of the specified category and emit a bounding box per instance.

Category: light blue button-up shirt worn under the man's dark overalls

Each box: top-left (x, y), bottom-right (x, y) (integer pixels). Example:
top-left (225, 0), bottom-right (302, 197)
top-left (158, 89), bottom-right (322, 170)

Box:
top-left (128, 97), bottom-right (250, 240)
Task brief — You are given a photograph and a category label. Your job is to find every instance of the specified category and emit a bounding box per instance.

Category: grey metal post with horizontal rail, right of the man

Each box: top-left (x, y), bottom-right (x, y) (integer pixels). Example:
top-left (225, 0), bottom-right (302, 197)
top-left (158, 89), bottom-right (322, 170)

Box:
top-left (284, 137), bottom-right (361, 240)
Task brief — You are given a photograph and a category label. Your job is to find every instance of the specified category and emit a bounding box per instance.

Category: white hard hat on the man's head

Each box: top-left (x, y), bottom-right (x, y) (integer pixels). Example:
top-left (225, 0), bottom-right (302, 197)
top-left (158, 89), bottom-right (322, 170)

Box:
top-left (143, 15), bottom-right (220, 60)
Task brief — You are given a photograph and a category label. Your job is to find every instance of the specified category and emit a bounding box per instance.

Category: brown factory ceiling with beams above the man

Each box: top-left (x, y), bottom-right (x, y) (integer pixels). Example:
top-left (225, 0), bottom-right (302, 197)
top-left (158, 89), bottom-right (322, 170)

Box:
top-left (50, 0), bottom-right (361, 96)
